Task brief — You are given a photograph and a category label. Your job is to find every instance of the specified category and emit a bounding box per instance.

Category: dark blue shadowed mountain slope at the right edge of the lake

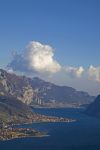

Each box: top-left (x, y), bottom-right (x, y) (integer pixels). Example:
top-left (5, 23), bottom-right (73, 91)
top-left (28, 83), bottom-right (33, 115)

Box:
top-left (85, 95), bottom-right (100, 118)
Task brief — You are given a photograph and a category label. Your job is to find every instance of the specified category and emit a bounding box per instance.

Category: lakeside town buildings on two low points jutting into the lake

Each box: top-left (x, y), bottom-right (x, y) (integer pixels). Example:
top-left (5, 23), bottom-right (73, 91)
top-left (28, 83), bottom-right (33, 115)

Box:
top-left (0, 114), bottom-right (75, 141)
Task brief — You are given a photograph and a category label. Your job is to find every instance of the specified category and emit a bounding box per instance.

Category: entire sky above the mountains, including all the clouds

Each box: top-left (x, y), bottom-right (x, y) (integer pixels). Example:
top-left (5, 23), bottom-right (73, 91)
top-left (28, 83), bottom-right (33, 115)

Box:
top-left (0, 0), bottom-right (100, 95)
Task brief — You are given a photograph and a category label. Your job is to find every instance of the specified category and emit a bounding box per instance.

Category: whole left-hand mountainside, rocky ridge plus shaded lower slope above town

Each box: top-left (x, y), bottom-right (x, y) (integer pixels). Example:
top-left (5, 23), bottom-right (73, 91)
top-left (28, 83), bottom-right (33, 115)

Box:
top-left (0, 69), bottom-right (94, 124)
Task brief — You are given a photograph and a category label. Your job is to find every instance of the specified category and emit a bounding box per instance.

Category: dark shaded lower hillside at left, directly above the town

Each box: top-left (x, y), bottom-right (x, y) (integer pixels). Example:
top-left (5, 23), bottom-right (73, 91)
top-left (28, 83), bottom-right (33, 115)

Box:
top-left (0, 96), bottom-right (32, 124)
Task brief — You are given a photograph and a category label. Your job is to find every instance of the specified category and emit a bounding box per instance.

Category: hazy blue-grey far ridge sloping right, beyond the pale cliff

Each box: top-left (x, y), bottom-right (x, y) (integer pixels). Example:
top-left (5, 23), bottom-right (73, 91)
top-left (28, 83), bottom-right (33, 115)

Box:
top-left (30, 77), bottom-right (94, 106)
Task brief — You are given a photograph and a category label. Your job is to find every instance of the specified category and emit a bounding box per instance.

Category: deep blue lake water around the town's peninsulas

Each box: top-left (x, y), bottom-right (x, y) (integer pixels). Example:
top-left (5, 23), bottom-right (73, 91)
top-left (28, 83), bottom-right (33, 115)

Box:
top-left (0, 109), bottom-right (100, 150)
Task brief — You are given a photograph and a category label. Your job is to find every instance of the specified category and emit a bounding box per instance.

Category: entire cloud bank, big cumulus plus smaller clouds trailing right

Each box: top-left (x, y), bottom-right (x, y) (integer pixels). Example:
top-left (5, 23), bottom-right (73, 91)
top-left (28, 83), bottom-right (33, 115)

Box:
top-left (7, 41), bottom-right (100, 82)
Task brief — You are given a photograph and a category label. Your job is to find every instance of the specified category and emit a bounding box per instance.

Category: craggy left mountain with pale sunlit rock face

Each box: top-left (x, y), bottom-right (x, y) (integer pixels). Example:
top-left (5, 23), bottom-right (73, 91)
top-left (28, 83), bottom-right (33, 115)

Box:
top-left (0, 70), bottom-right (34, 105)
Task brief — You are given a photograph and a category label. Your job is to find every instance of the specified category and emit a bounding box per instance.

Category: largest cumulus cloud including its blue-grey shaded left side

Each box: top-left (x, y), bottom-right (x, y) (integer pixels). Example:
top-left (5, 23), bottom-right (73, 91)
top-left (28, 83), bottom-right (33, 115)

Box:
top-left (8, 41), bottom-right (61, 73)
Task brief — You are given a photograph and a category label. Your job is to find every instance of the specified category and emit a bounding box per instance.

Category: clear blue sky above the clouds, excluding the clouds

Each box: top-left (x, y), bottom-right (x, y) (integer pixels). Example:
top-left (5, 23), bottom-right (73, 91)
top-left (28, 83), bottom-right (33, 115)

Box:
top-left (0, 0), bottom-right (100, 95)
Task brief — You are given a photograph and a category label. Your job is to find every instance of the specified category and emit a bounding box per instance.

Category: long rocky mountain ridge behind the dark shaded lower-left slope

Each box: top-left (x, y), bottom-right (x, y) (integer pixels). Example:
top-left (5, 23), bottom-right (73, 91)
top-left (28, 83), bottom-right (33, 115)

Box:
top-left (0, 69), bottom-right (94, 107)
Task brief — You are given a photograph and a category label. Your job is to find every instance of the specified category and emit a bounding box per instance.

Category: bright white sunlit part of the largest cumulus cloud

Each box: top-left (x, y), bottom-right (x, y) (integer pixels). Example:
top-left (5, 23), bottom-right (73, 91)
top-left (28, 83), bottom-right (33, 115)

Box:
top-left (25, 41), bottom-right (61, 73)
